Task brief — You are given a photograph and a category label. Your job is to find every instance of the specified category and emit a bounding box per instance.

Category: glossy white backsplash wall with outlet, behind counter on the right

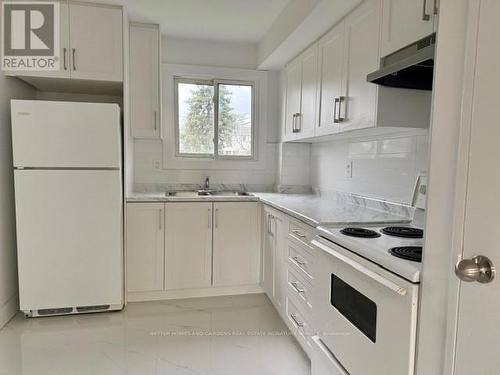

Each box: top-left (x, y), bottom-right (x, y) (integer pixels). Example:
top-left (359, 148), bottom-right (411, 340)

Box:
top-left (310, 131), bottom-right (428, 203)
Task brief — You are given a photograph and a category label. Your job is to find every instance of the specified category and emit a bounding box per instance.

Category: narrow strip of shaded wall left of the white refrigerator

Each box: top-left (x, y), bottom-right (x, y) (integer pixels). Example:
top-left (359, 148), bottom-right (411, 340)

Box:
top-left (0, 74), bottom-right (35, 328)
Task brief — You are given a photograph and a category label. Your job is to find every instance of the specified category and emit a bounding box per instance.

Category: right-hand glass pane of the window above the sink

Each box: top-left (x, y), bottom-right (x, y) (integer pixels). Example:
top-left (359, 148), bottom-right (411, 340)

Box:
top-left (218, 84), bottom-right (253, 156)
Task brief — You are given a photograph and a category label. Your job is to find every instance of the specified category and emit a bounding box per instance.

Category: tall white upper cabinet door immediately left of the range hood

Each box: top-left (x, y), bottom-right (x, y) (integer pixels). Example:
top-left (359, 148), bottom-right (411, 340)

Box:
top-left (340, 0), bottom-right (381, 131)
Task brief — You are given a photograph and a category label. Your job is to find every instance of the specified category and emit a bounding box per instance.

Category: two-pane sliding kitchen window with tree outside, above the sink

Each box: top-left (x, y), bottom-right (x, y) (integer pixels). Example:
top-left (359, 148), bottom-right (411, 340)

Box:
top-left (174, 78), bottom-right (255, 159)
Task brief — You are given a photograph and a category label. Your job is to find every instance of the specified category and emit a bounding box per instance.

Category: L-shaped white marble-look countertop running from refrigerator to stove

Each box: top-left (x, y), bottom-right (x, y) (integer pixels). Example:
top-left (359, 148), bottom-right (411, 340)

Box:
top-left (126, 192), bottom-right (410, 227)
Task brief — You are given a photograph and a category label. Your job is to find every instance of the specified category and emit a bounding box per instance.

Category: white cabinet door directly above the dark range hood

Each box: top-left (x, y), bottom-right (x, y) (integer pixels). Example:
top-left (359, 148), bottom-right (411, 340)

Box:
top-left (381, 0), bottom-right (435, 56)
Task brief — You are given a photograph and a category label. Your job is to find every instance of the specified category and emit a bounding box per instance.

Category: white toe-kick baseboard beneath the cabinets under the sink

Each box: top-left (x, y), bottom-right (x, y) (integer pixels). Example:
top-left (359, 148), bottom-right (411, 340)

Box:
top-left (127, 285), bottom-right (264, 302)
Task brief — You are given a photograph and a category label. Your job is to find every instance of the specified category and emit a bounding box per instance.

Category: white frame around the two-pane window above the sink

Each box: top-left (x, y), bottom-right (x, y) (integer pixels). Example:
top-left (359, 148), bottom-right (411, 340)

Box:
top-left (174, 76), bottom-right (257, 160)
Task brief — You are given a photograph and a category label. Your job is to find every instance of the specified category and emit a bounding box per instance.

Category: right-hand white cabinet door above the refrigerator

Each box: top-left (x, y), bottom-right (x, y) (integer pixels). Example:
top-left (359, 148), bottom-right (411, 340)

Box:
top-left (69, 2), bottom-right (123, 82)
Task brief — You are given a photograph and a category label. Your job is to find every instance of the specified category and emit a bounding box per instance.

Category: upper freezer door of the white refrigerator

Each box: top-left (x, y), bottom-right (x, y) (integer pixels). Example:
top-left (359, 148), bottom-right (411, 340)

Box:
top-left (11, 100), bottom-right (121, 168)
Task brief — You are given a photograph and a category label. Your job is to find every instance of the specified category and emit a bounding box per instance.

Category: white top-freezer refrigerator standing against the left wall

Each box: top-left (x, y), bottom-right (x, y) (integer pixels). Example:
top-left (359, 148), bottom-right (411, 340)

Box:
top-left (11, 100), bottom-right (123, 317)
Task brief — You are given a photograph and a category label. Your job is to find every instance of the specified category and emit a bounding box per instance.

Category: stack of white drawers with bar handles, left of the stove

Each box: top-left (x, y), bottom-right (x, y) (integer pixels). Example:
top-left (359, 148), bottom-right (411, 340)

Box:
top-left (285, 220), bottom-right (314, 355)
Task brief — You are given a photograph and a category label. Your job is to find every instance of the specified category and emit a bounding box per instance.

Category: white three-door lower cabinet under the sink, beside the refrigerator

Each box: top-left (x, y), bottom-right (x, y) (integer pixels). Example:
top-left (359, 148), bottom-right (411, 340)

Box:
top-left (126, 202), bottom-right (260, 301)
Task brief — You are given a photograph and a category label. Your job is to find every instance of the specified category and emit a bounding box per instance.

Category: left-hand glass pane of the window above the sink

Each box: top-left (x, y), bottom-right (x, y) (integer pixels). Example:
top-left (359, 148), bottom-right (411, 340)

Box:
top-left (177, 82), bottom-right (214, 154)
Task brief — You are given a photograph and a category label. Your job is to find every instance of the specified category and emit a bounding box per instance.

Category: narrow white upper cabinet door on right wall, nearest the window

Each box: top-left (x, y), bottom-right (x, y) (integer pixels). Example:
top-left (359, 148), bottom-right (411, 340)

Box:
top-left (283, 59), bottom-right (302, 141)
